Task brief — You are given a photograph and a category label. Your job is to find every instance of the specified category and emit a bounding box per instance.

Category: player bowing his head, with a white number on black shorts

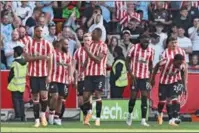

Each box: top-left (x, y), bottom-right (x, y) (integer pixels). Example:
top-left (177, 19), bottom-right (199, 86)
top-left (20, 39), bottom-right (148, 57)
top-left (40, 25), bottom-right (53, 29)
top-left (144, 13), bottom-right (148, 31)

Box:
top-left (151, 54), bottom-right (186, 126)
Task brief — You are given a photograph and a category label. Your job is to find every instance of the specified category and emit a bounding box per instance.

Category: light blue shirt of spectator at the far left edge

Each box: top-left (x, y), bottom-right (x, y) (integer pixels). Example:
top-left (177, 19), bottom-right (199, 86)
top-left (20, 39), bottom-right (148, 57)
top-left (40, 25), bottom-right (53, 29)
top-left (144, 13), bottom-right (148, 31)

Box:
top-left (1, 24), bottom-right (13, 43)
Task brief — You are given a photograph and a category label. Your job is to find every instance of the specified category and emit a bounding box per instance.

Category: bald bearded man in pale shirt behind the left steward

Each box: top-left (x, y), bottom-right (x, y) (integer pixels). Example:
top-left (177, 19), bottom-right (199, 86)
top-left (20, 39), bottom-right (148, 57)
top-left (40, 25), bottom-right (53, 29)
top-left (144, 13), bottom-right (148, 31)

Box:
top-left (4, 30), bottom-right (24, 68)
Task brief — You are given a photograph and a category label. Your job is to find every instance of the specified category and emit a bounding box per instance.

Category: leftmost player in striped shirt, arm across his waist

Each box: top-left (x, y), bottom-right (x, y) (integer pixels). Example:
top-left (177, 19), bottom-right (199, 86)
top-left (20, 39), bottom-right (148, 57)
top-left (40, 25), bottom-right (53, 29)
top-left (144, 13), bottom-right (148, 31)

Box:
top-left (24, 26), bottom-right (54, 127)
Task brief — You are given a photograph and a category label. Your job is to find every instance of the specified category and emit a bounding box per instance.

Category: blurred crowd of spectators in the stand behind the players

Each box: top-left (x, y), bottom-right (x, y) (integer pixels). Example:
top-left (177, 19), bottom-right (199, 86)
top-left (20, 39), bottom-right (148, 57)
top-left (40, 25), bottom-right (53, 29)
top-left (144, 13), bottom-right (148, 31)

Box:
top-left (0, 1), bottom-right (199, 72)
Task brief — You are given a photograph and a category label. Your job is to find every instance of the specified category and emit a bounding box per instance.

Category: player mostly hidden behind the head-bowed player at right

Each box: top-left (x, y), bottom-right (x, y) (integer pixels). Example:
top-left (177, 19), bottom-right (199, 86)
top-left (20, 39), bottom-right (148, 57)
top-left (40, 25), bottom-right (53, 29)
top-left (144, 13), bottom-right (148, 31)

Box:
top-left (157, 37), bottom-right (187, 125)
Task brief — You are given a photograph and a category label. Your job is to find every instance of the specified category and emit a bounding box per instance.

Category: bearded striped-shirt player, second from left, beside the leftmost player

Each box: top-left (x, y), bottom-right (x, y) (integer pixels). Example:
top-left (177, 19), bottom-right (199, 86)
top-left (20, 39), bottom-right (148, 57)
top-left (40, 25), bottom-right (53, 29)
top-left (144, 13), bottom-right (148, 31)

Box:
top-left (49, 39), bottom-right (72, 125)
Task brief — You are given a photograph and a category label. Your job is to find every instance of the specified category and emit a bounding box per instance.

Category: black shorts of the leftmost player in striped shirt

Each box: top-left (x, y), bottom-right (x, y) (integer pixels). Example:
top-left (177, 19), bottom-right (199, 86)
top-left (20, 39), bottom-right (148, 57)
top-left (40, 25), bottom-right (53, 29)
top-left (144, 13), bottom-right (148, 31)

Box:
top-left (30, 77), bottom-right (48, 94)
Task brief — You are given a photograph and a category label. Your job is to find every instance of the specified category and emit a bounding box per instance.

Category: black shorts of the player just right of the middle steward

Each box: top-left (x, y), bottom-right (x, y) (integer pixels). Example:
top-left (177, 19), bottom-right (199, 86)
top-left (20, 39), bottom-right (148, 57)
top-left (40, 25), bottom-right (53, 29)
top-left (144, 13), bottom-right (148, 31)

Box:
top-left (131, 79), bottom-right (151, 91)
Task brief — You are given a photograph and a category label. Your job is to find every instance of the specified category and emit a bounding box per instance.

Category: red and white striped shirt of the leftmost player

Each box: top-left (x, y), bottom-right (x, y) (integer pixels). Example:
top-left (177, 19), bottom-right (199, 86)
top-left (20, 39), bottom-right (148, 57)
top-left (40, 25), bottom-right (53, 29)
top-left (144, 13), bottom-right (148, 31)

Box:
top-left (25, 39), bottom-right (54, 77)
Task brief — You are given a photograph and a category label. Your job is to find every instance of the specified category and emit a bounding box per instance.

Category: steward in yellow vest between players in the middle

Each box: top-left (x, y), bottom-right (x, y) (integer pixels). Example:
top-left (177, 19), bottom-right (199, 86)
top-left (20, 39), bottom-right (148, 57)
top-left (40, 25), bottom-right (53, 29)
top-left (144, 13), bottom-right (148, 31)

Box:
top-left (110, 46), bottom-right (128, 98)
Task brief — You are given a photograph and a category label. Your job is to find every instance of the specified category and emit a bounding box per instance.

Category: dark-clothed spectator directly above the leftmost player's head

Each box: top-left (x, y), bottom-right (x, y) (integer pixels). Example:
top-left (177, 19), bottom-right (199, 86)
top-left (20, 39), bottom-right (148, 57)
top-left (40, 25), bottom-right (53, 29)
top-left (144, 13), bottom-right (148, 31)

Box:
top-left (26, 7), bottom-right (41, 31)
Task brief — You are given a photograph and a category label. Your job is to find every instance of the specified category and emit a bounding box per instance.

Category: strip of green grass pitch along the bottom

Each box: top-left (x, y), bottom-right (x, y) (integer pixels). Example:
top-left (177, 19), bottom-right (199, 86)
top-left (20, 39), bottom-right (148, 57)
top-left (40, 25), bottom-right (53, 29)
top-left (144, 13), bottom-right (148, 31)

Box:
top-left (1, 121), bottom-right (199, 132)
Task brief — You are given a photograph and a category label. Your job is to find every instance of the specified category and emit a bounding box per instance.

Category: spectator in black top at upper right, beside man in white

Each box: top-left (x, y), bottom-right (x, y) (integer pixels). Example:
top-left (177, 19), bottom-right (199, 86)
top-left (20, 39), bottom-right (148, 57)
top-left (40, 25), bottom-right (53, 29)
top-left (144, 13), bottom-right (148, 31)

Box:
top-left (173, 7), bottom-right (191, 36)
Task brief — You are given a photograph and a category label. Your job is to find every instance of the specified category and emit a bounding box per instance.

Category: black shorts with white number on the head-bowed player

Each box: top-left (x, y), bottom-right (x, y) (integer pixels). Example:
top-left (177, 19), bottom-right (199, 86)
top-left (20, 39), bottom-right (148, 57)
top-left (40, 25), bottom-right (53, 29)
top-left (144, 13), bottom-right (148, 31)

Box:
top-left (158, 82), bottom-right (184, 101)
